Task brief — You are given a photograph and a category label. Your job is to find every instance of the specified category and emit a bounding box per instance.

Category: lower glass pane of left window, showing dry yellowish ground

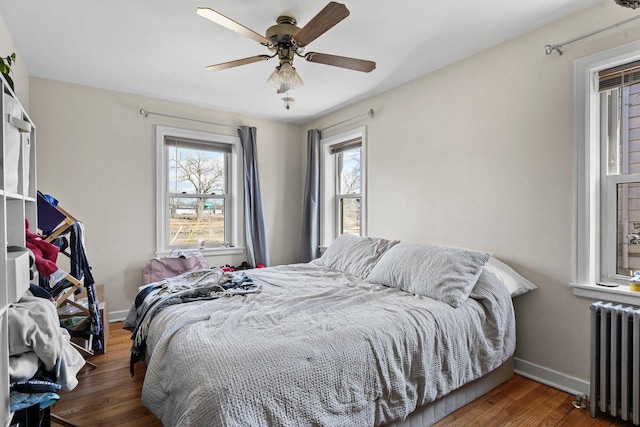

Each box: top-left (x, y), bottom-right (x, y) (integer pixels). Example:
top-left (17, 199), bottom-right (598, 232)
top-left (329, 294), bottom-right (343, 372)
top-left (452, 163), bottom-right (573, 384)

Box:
top-left (169, 197), bottom-right (225, 247)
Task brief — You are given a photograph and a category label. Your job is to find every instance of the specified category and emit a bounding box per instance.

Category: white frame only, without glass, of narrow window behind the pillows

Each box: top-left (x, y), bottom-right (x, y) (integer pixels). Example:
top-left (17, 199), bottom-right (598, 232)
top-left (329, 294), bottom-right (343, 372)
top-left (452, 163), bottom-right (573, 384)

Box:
top-left (320, 126), bottom-right (367, 247)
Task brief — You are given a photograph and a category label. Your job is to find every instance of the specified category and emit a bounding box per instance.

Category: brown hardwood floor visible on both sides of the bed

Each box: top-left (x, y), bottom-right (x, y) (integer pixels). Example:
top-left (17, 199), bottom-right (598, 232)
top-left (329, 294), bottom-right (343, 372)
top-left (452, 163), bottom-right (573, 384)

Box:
top-left (52, 323), bottom-right (628, 427)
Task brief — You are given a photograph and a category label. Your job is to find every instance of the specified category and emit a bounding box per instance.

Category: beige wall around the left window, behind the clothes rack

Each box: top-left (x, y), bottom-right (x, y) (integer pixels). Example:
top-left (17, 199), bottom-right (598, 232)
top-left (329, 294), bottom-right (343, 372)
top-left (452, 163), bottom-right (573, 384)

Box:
top-left (30, 78), bottom-right (303, 317)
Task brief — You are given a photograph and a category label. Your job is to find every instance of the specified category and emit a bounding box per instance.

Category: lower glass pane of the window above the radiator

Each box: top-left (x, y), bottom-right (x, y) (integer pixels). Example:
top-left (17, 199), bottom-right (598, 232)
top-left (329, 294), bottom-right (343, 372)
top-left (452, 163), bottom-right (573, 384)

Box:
top-left (616, 183), bottom-right (640, 276)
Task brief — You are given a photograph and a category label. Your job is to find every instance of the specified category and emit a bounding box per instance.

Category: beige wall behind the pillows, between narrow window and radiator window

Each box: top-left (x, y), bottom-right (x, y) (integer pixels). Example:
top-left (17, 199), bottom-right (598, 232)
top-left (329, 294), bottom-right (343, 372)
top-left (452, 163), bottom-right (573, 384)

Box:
top-left (304, 2), bottom-right (640, 381)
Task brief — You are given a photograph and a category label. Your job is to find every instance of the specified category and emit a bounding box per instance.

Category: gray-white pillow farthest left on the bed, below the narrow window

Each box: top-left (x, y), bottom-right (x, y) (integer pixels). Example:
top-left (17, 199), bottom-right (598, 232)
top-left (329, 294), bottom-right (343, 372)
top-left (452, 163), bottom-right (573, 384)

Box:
top-left (311, 234), bottom-right (399, 280)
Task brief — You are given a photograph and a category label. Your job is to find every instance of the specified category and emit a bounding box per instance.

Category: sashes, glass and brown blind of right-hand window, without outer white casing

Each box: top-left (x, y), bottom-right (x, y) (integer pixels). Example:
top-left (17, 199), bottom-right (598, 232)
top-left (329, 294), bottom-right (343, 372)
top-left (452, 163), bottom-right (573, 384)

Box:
top-left (598, 62), bottom-right (640, 281)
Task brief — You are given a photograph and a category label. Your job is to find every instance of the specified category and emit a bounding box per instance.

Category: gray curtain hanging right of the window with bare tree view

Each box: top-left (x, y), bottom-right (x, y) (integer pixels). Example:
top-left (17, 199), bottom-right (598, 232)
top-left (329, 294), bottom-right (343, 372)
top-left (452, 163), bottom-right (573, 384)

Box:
top-left (238, 126), bottom-right (270, 266)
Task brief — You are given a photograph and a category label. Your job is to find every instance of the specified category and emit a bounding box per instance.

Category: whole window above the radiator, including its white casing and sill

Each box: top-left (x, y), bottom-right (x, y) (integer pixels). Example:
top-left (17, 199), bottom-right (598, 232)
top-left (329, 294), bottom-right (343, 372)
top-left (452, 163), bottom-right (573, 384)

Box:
top-left (573, 43), bottom-right (640, 304)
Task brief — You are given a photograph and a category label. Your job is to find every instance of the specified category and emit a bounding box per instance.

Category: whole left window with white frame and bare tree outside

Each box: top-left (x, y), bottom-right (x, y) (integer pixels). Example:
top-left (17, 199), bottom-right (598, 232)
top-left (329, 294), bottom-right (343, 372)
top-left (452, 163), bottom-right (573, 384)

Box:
top-left (157, 127), bottom-right (241, 253)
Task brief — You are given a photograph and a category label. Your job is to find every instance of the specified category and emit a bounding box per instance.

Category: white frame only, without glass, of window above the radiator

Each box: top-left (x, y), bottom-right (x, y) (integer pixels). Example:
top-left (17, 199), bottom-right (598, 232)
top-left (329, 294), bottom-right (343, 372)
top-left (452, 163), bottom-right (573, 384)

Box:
top-left (571, 42), bottom-right (640, 305)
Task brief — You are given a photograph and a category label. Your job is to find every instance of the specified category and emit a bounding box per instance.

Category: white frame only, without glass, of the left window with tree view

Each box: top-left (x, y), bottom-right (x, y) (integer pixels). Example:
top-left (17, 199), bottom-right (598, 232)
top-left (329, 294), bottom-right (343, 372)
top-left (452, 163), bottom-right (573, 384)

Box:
top-left (156, 126), bottom-right (244, 256)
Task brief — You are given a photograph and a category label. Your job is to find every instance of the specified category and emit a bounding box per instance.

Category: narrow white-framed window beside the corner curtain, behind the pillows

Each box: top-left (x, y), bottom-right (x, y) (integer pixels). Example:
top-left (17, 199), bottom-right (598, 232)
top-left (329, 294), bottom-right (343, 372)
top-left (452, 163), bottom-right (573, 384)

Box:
top-left (320, 128), bottom-right (366, 246)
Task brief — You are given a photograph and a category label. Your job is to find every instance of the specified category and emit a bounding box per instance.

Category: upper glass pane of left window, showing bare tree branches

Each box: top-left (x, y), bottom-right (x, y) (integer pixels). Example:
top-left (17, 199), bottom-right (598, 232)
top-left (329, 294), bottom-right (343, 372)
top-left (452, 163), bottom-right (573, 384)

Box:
top-left (167, 144), bottom-right (226, 194)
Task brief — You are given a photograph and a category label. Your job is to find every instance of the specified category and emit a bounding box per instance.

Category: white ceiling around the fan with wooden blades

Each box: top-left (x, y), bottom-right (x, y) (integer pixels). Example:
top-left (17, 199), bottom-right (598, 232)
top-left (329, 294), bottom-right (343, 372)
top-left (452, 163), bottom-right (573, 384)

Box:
top-left (0, 0), bottom-right (599, 123)
